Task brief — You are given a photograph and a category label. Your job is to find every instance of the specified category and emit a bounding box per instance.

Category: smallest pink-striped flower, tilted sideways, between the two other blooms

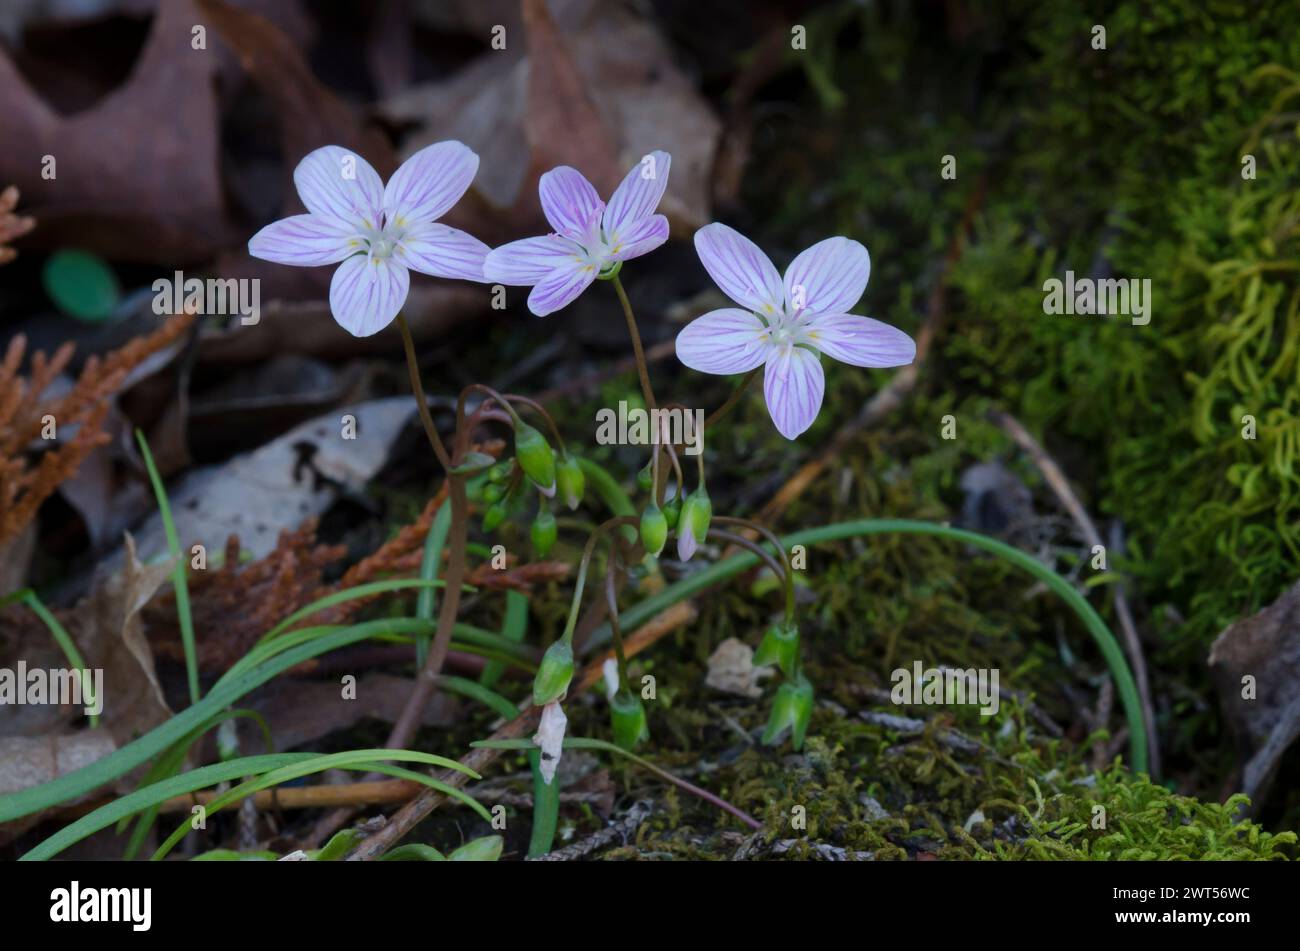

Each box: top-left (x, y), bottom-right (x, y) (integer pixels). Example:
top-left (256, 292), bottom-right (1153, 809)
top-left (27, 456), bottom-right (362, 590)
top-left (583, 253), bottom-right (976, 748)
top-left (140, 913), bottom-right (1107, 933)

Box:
top-left (484, 152), bottom-right (672, 317)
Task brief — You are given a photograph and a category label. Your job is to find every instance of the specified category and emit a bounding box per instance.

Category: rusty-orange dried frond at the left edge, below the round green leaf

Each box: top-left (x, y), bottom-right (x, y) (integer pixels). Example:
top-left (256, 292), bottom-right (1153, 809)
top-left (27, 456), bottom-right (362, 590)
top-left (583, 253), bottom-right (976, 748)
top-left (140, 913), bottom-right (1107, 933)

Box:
top-left (0, 317), bottom-right (192, 542)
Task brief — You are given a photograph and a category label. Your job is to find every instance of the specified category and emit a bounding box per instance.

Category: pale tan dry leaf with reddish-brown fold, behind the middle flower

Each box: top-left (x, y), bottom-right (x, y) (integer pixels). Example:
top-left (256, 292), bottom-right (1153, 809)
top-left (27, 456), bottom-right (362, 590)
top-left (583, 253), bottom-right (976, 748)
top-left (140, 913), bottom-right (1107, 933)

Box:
top-left (380, 0), bottom-right (722, 239)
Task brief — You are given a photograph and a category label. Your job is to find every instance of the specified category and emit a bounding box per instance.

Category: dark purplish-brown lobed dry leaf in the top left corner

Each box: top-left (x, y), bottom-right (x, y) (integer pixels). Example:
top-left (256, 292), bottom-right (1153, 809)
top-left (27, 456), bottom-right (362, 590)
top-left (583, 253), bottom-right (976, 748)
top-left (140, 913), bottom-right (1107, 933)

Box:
top-left (0, 0), bottom-right (237, 264)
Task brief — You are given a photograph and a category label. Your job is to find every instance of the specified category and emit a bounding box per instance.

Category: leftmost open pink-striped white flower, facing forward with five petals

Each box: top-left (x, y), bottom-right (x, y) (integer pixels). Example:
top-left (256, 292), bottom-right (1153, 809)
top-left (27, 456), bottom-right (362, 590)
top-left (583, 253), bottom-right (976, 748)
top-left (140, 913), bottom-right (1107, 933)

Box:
top-left (248, 142), bottom-right (489, 336)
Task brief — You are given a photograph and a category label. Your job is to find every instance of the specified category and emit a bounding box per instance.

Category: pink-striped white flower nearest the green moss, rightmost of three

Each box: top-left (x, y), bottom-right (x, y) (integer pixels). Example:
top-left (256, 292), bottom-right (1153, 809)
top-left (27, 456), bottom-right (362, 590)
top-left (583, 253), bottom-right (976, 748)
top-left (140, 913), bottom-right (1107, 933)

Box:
top-left (677, 222), bottom-right (917, 439)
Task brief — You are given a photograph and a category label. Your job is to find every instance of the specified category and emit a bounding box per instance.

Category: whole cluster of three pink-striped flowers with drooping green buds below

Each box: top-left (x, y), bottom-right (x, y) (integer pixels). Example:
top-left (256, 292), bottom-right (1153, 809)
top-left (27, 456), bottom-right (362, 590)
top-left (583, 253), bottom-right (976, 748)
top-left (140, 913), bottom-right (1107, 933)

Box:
top-left (248, 142), bottom-right (917, 782)
